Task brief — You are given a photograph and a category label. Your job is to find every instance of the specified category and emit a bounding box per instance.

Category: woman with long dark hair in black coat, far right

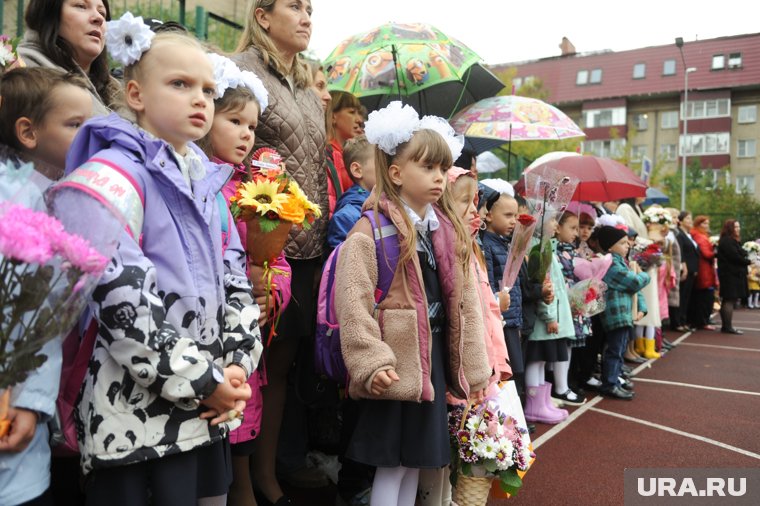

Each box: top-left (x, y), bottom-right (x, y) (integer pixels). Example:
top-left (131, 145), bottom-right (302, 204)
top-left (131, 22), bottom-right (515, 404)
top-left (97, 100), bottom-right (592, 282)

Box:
top-left (718, 220), bottom-right (750, 334)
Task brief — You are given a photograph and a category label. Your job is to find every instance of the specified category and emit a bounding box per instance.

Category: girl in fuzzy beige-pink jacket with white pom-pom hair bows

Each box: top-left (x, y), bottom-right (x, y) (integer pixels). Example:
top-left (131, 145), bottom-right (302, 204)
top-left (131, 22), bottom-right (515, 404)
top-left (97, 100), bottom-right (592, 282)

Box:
top-left (335, 102), bottom-right (491, 506)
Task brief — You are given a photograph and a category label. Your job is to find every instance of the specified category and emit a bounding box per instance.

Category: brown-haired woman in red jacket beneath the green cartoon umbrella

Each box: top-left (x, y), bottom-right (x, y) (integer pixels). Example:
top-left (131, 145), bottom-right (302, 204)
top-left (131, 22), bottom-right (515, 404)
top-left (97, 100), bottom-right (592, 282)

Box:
top-left (326, 91), bottom-right (363, 216)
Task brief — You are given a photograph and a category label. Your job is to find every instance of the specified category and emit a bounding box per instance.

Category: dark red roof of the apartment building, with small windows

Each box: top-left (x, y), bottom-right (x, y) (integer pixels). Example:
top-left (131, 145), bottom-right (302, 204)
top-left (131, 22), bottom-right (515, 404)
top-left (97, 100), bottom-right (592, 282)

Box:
top-left (492, 33), bottom-right (760, 104)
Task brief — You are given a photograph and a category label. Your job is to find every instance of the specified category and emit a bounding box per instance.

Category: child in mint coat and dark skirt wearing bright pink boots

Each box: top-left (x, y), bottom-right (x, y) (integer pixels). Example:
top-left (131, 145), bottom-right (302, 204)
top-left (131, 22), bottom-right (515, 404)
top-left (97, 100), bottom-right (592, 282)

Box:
top-left (525, 217), bottom-right (580, 424)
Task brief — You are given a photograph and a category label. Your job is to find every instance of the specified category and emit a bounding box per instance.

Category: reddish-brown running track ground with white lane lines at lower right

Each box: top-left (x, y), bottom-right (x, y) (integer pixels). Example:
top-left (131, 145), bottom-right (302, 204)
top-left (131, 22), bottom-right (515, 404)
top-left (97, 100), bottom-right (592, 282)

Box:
top-left (498, 310), bottom-right (760, 506)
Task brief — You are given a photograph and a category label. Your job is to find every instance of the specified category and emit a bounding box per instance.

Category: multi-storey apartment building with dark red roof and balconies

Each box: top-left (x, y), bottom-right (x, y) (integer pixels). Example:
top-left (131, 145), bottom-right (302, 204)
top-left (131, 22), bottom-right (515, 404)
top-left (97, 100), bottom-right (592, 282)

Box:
top-left (491, 33), bottom-right (760, 197)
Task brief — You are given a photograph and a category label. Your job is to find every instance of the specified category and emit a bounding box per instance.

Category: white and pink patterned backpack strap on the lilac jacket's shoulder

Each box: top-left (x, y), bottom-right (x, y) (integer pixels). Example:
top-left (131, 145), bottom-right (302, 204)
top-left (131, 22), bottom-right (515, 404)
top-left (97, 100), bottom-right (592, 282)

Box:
top-left (54, 158), bottom-right (145, 243)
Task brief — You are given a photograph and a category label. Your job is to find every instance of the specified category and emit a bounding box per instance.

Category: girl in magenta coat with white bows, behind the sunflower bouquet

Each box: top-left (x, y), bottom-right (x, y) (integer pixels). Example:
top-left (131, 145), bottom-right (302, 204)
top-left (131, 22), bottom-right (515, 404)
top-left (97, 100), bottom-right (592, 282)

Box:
top-left (198, 54), bottom-right (290, 505)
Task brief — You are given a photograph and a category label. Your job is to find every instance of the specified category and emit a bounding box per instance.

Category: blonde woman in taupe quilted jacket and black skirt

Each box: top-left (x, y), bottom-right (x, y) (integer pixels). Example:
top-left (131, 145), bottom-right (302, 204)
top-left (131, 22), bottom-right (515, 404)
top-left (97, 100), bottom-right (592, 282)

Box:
top-left (232, 0), bottom-right (327, 504)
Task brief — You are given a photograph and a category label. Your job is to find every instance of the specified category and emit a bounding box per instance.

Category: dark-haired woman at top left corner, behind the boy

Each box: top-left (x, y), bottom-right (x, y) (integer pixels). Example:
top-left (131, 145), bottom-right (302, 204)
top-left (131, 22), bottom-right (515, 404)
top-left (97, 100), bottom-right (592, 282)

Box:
top-left (18, 0), bottom-right (120, 116)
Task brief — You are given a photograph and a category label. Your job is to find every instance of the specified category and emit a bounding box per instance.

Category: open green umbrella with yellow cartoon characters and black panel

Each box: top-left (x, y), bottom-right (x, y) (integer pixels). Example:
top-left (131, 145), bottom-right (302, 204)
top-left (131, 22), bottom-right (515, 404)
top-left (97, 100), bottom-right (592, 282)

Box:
top-left (325, 23), bottom-right (504, 118)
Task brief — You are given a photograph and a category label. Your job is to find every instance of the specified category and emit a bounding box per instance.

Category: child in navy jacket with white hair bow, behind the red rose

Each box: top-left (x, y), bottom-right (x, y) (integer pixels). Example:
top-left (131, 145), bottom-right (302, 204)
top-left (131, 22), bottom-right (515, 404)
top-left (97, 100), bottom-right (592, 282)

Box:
top-left (481, 181), bottom-right (525, 396)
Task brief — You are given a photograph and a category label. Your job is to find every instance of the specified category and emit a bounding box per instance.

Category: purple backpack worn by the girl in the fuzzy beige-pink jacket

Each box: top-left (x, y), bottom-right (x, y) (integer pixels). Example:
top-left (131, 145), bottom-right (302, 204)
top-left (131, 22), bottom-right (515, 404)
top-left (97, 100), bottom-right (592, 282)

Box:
top-left (314, 211), bottom-right (400, 385)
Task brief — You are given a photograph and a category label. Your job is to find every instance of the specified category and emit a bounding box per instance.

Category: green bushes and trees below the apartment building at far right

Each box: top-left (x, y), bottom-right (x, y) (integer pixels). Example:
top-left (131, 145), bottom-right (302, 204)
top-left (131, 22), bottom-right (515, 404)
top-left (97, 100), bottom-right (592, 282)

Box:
top-left (662, 159), bottom-right (760, 240)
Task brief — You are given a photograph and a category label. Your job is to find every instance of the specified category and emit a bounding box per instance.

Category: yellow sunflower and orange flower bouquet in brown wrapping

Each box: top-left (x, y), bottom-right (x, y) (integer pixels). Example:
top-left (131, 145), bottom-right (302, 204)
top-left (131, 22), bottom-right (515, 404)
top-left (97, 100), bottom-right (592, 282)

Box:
top-left (230, 148), bottom-right (322, 266)
